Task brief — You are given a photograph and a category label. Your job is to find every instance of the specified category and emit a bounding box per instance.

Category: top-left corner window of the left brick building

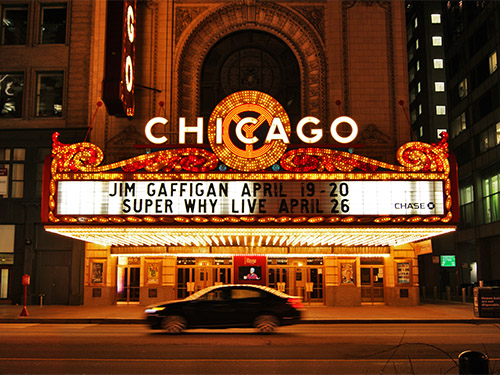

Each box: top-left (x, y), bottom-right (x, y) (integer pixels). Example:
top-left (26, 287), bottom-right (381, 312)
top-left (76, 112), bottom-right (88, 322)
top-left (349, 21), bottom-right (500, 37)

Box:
top-left (2, 4), bottom-right (28, 45)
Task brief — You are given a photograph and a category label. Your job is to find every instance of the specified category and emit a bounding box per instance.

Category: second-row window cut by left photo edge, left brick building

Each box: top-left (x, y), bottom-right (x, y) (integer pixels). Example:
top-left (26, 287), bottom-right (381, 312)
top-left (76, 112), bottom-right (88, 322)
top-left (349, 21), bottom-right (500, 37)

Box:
top-left (0, 73), bottom-right (24, 118)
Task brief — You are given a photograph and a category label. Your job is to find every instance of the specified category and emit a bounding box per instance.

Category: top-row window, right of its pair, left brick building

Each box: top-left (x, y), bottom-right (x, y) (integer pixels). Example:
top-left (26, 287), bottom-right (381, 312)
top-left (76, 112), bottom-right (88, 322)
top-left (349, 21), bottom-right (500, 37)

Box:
top-left (40, 4), bottom-right (66, 44)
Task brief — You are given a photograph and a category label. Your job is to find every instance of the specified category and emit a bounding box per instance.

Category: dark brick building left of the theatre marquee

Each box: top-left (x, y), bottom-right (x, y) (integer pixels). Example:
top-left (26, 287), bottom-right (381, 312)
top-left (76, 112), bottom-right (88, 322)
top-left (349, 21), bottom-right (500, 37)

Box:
top-left (0, 1), bottom-right (92, 304)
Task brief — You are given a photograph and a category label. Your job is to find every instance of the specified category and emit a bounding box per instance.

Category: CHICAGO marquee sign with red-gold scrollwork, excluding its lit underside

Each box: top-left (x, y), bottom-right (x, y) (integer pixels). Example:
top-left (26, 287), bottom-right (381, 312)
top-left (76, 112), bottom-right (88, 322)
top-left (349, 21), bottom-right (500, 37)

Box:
top-left (42, 91), bottom-right (458, 231)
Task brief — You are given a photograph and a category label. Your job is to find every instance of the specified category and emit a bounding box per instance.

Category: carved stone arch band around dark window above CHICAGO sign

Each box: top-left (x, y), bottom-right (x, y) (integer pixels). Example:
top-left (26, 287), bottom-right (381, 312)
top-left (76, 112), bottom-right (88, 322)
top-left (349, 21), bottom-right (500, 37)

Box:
top-left (174, 1), bottom-right (328, 125)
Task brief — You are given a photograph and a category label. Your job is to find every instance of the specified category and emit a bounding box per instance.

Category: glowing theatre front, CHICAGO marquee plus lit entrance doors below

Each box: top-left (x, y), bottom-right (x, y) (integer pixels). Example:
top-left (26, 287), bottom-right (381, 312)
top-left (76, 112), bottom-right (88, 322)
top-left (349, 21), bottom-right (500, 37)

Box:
top-left (42, 91), bottom-right (458, 306)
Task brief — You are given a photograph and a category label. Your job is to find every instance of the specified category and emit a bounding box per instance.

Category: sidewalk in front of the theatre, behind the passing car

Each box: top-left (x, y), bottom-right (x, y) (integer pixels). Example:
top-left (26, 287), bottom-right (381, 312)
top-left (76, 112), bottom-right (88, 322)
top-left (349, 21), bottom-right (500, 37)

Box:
top-left (0, 303), bottom-right (492, 324)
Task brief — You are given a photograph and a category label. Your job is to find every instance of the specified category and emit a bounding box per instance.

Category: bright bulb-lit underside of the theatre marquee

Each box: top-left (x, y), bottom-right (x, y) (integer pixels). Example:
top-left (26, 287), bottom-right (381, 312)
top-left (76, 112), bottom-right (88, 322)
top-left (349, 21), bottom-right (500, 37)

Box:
top-left (45, 225), bottom-right (455, 247)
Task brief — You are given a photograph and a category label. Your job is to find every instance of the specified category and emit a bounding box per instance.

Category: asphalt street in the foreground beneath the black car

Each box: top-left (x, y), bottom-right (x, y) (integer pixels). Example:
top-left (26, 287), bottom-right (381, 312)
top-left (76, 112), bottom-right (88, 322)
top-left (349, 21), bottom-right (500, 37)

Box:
top-left (0, 323), bottom-right (500, 374)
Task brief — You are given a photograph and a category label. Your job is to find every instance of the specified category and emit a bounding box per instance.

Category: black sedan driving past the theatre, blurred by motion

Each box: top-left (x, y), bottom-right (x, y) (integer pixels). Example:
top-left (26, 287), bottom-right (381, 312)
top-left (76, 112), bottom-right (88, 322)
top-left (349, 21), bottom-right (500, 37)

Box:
top-left (145, 284), bottom-right (304, 333)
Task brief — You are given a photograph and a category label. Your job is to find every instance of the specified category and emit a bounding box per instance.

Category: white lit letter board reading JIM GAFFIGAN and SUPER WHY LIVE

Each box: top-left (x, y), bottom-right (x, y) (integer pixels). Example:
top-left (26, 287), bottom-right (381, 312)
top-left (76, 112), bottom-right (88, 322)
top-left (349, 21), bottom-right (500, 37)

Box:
top-left (57, 181), bottom-right (445, 216)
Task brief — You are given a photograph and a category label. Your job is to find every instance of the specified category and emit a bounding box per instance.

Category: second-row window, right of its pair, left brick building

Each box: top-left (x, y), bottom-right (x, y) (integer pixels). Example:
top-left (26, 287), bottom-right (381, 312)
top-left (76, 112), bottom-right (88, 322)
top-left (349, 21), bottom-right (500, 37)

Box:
top-left (35, 72), bottom-right (64, 117)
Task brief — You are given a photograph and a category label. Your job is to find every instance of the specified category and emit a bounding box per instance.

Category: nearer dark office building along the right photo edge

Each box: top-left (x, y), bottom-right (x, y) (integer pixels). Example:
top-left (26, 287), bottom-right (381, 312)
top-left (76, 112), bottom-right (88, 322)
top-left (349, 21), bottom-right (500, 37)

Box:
top-left (442, 1), bottom-right (500, 284)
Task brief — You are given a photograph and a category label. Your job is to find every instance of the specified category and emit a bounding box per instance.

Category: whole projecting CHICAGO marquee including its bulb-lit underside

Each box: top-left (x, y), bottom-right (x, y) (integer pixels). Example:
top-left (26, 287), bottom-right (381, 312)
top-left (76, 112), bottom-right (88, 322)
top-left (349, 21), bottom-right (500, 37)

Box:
top-left (42, 92), bottom-right (458, 250)
